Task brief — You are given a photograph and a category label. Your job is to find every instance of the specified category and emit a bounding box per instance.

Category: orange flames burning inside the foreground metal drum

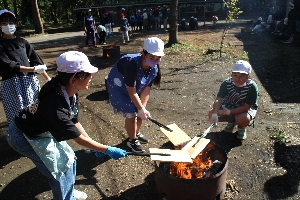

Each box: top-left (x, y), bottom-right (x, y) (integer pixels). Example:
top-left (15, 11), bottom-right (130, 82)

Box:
top-left (170, 143), bottom-right (214, 179)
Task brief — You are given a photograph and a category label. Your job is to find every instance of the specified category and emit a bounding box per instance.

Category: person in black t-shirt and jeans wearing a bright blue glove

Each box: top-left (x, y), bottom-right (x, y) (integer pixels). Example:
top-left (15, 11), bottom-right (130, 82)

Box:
top-left (7, 51), bottom-right (126, 200)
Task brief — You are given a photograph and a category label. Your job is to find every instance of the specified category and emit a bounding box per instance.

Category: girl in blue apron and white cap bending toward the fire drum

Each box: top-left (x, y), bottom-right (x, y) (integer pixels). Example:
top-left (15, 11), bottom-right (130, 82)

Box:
top-left (107, 37), bottom-right (165, 152)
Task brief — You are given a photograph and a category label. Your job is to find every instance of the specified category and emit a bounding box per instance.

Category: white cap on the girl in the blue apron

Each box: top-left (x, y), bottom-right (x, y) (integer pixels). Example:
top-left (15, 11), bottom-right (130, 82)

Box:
top-left (144, 37), bottom-right (165, 56)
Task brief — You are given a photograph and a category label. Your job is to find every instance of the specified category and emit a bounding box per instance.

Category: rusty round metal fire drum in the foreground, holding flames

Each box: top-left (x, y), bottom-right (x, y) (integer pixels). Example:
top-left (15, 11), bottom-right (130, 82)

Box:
top-left (155, 142), bottom-right (229, 200)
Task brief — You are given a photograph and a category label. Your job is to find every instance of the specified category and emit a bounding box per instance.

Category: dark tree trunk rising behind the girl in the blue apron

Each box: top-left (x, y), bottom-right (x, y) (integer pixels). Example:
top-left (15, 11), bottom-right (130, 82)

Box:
top-left (168, 0), bottom-right (178, 46)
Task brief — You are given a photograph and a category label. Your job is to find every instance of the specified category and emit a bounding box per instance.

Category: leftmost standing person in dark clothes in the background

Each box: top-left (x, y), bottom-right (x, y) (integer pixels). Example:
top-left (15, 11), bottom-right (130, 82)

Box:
top-left (83, 9), bottom-right (97, 47)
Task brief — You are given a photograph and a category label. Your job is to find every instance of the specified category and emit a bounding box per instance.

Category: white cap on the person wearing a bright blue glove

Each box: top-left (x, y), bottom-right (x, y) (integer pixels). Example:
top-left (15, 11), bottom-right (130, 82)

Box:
top-left (56, 51), bottom-right (98, 74)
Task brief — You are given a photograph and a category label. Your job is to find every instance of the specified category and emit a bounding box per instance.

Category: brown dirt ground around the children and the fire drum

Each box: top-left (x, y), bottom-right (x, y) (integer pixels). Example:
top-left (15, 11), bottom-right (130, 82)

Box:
top-left (0, 16), bottom-right (300, 200)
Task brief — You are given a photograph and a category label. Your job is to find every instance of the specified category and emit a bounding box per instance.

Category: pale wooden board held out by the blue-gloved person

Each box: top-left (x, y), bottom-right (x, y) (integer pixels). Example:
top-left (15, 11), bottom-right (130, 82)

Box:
top-left (149, 148), bottom-right (193, 163)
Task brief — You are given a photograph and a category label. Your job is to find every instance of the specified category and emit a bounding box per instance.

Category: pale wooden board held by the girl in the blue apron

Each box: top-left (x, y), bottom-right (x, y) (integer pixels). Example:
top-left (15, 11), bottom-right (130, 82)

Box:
top-left (160, 124), bottom-right (191, 146)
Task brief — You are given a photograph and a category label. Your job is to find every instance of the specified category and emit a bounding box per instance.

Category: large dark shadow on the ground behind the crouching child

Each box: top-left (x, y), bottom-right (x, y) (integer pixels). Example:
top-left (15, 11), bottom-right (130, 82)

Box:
top-left (236, 20), bottom-right (300, 103)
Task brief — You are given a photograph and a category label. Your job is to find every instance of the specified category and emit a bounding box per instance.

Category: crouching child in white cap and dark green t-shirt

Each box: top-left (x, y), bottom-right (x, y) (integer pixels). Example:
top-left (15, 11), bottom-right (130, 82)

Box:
top-left (208, 60), bottom-right (258, 139)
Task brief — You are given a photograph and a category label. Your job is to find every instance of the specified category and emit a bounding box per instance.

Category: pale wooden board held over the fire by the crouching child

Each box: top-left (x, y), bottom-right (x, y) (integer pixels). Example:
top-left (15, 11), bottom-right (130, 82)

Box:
top-left (182, 137), bottom-right (210, 159)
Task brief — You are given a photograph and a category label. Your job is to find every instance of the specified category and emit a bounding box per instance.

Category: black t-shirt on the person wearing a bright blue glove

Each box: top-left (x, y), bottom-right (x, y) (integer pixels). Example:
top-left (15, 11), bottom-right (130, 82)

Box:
top-left (15, 91), bottom-right (81, 142)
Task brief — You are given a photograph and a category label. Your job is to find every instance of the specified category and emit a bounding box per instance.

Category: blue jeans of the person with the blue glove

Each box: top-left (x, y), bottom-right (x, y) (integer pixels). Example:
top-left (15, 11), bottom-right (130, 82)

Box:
top-left (7, 122), bottom-right (76, 200)
